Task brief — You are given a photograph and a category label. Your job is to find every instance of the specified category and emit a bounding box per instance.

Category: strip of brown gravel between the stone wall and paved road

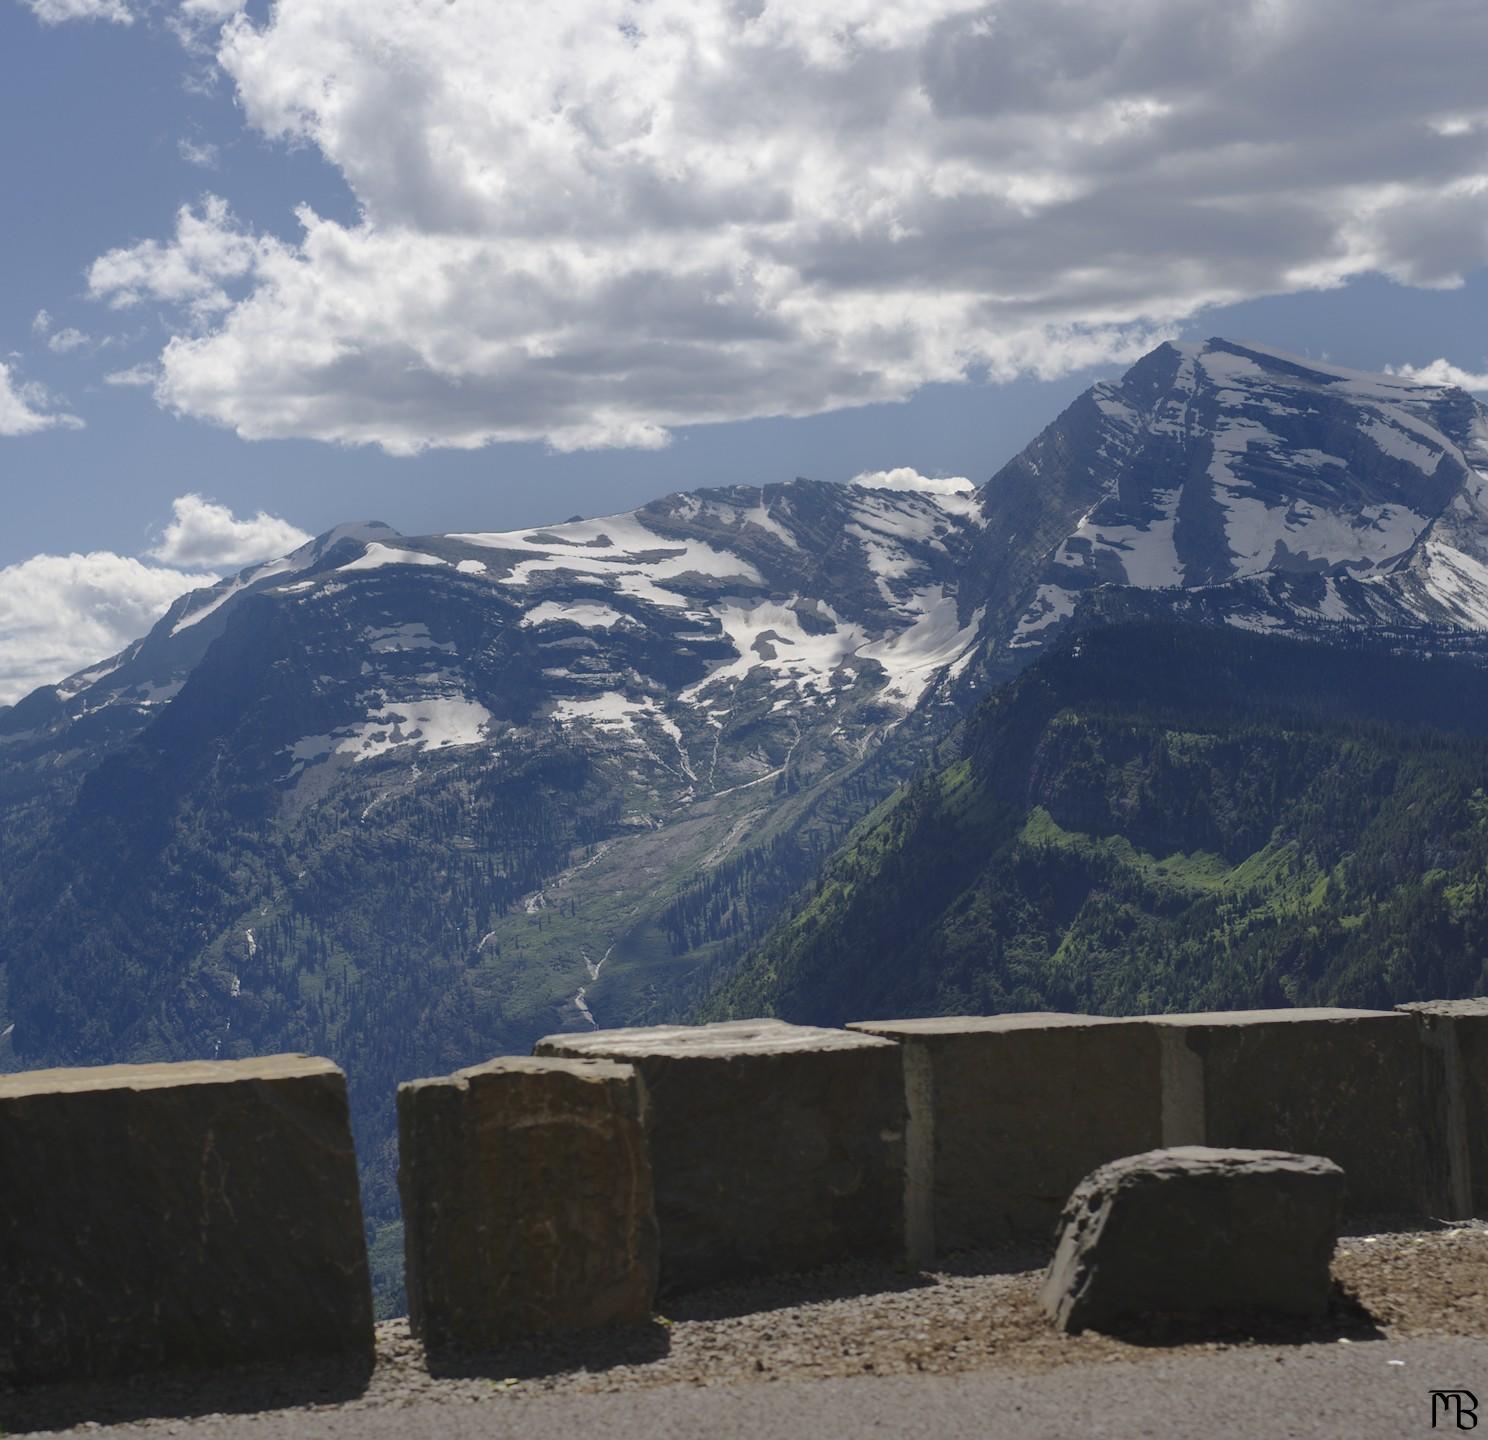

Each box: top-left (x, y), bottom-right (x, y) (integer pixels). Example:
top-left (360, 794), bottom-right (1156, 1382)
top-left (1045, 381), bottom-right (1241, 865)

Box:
top-left (11, 1223), bottom-right (1488, 1434)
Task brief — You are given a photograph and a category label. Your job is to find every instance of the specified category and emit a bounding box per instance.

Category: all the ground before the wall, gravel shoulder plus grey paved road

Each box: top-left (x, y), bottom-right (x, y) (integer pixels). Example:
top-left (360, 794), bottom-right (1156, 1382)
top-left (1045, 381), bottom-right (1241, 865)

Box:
top-left (0, 1227), bottom-right (1488, 1440)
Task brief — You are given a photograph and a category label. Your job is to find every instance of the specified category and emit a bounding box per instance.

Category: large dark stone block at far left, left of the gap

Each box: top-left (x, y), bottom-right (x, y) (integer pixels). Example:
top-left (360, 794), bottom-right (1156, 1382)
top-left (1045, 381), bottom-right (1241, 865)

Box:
top-left (0, 1055), bottom-right (372, 1380)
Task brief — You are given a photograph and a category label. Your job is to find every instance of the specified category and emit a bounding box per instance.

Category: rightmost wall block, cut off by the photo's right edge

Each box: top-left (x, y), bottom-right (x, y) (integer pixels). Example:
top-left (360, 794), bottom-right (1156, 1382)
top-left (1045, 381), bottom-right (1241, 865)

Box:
top-left (1396, 1000), bottom-right (1488, 1220)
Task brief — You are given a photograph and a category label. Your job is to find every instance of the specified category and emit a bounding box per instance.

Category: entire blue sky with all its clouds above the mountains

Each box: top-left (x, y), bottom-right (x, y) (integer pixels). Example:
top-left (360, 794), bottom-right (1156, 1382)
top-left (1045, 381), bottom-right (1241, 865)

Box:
top-left (0, 0), bottom-right (1488, 702)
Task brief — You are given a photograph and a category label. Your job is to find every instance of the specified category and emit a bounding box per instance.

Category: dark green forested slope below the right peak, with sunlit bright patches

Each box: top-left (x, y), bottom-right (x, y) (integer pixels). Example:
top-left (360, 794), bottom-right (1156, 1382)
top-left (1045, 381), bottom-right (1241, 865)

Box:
top-left (702, 623), bottom-right (1488, 1023)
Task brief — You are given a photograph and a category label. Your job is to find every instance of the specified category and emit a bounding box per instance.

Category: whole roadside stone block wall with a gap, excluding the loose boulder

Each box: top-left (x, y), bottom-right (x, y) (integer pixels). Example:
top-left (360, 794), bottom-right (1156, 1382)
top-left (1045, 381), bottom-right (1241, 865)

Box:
top-left (0, 1000), bottom-right (1488, 1380)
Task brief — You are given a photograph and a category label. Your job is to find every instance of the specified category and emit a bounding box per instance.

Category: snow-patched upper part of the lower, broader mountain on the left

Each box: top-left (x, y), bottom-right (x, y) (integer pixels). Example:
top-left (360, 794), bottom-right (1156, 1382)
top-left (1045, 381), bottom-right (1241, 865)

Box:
top-left (6, 480), bottom-right (982, 794)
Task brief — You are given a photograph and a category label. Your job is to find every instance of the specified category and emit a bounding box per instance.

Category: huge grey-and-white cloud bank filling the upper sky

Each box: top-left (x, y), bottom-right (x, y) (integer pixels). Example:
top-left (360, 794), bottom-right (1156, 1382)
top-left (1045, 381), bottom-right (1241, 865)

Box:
top-left (78, 0), bottom-right (1488, 452)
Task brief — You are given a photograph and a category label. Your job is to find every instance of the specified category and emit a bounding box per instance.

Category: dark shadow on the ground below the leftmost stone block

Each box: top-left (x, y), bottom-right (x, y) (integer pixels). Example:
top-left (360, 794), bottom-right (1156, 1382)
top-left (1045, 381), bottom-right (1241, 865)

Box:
top-left (0, 1355), bottom-right (372, 1436)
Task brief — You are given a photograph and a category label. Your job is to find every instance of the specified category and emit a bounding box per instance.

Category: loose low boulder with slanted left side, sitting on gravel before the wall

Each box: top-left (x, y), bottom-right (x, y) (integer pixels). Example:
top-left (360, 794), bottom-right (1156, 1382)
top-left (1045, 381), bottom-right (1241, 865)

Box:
top-left (1039, 1145), bottom-right (1344, 1331)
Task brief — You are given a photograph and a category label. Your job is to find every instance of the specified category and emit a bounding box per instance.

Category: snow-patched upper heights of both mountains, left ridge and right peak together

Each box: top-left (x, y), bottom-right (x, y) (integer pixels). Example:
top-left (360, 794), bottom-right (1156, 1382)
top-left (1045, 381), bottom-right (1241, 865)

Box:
top-left (14, 339), bottom-right (1488, 799)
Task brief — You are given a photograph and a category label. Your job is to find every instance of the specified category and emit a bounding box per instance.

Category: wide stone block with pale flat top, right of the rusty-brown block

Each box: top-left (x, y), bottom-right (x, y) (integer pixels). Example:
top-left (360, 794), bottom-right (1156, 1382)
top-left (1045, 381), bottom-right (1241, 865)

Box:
top-left (537, 1020), bottom-right (905, 1290)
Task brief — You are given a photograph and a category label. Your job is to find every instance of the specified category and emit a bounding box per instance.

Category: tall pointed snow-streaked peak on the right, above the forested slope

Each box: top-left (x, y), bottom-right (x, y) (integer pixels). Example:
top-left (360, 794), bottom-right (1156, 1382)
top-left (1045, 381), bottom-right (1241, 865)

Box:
top-left (988, 339), bottom-right (1488, 649)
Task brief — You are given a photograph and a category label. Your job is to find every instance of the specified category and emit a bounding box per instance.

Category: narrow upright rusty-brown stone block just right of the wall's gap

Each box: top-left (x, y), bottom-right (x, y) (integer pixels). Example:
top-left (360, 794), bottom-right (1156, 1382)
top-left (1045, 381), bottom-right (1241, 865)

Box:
top-left (397, 1058), bottom-right (656, 1349)
